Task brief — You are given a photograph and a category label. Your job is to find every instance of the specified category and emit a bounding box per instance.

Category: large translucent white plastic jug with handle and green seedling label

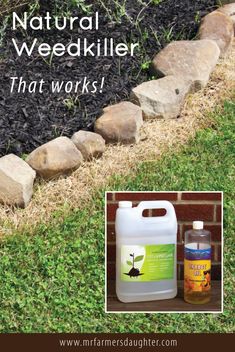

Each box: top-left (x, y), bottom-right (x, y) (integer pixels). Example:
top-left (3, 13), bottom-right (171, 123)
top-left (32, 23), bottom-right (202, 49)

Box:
top-left (115, 201), bottom-right (177, 302)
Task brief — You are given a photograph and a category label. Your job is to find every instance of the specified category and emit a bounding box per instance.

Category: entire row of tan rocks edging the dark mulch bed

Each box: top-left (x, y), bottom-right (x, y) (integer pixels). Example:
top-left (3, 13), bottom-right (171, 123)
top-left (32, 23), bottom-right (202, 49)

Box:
top-left (0, 3), bottom-right (235, 208)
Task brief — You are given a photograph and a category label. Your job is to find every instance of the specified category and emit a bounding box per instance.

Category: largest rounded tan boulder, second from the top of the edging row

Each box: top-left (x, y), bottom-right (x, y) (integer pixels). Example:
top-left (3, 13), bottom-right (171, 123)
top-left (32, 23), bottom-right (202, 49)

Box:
top-left (152, 40), bottom-right (220, 92)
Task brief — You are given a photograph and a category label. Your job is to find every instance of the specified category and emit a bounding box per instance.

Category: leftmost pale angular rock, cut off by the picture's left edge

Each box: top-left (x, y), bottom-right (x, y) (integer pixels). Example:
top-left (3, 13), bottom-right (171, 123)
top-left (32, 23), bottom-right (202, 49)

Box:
top-left (0, 154), bottom-right (36, 208)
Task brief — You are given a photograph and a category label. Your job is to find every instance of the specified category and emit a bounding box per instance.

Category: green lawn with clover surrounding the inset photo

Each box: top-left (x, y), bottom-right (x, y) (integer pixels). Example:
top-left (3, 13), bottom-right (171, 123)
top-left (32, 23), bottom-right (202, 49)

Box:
top-left (0, 102), bottom-right (235, 333)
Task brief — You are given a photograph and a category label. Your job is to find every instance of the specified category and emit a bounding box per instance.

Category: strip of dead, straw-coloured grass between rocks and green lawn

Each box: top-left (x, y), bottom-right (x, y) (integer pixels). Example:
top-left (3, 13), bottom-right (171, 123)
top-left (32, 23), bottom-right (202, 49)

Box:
top-left (0, 42), bottom-right (235, 235)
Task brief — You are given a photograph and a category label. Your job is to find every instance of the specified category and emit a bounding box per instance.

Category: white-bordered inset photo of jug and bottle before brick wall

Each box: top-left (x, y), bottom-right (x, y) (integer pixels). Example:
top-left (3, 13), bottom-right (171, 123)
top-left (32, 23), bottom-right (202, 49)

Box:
top-left (105, 192), bottom-right (223, 313)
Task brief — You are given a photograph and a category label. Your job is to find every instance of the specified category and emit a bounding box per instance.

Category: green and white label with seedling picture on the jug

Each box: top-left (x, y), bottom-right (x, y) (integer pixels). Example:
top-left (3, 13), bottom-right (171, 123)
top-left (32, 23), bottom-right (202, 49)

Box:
top-left (121, 244), bottom-right (175, 282)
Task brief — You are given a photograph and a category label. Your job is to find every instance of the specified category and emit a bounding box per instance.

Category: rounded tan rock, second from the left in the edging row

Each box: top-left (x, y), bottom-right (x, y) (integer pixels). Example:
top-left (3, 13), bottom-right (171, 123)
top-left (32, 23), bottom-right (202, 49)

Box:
top-left (26, 137), bottom-right (83, 179)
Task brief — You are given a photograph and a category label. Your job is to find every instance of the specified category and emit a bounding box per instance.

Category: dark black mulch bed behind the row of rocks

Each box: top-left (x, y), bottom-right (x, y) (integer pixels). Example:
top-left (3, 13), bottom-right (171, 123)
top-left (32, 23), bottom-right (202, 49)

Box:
top-left (0, 0), bottom-right (217, 156)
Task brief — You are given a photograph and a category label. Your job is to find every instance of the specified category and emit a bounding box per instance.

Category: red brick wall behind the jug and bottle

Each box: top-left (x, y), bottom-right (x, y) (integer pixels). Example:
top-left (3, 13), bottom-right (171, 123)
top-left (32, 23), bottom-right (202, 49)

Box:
top-left (106, 192), bottom-right (222, 280)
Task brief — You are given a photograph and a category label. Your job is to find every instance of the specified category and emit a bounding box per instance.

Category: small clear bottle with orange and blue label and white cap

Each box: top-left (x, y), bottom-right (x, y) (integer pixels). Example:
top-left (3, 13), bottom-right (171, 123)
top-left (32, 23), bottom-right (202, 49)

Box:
top-left (184, 221), bottom-right (211, 304)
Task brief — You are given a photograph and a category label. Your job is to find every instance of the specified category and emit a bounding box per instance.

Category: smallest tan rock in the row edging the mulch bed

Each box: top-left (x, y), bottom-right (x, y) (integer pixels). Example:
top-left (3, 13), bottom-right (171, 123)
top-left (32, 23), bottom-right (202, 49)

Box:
top-left (71, 131), bottom-right (105, 160)
